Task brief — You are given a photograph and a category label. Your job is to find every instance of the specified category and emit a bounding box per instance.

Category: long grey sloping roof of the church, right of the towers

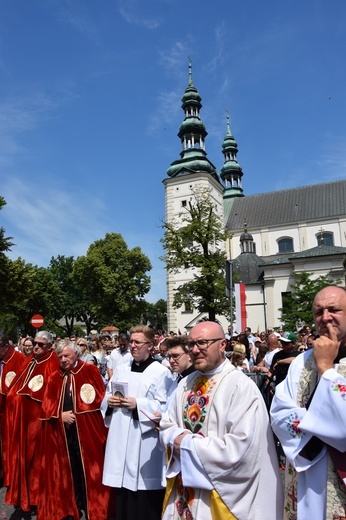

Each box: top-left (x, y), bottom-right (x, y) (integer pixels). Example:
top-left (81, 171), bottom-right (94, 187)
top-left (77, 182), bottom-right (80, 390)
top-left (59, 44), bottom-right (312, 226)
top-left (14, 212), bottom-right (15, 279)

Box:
top-left (227, 180), bottom-right (346, 230)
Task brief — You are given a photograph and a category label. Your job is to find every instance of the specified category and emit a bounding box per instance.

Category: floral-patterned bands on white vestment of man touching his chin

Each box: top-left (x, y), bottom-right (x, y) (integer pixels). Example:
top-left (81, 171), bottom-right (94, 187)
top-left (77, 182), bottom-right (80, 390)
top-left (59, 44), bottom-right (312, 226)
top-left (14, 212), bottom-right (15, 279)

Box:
top-left (285, 355), bottom-right (346, 520)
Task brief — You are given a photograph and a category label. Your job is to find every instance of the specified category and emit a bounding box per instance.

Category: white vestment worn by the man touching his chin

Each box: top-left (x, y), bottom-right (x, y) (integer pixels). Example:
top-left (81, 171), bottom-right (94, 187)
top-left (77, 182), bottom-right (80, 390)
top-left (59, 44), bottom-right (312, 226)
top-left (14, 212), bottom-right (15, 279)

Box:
top-left (271, 350), bottom-right (346, 520)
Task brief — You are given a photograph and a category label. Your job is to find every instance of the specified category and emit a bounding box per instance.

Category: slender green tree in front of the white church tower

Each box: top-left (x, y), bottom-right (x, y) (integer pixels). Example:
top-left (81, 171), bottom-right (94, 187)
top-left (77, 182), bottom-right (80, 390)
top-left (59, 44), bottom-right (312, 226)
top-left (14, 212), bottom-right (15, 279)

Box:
top-left (161, 188), bottom-right (230, 321)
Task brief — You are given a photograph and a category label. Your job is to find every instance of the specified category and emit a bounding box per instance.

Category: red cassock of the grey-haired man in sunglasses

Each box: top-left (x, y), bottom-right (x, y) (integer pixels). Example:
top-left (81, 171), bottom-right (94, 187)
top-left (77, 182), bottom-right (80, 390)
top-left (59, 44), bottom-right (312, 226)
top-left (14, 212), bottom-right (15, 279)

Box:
top-left (4, 351), bottom-right (59, 511)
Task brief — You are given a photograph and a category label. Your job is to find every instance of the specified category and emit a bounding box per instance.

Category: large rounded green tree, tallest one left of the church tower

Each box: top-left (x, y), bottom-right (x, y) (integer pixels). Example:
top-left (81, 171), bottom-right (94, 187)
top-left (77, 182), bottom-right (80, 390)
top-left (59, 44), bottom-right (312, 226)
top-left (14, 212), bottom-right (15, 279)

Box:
top-left (73, 233), bottom-right (151, 330)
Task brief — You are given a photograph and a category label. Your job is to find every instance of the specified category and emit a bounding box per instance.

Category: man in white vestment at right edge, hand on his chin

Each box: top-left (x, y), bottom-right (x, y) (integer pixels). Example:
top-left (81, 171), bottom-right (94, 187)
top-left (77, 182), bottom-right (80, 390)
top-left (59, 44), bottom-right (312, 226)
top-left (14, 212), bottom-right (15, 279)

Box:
top-left (271, 287), bottom-right (346, 520)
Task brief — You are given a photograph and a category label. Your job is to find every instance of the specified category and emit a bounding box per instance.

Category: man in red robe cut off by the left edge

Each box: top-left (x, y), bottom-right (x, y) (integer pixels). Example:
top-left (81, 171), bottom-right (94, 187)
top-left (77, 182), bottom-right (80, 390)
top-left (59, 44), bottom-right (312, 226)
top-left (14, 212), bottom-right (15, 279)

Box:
top-left (0, 332), bottom-right (26, 479)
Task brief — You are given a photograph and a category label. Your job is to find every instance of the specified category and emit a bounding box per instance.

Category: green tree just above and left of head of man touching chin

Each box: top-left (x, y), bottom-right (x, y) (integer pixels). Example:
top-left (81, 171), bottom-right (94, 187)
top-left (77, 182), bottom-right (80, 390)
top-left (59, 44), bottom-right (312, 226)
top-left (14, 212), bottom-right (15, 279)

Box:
top-left (279, 271), bottom-right (341, 330)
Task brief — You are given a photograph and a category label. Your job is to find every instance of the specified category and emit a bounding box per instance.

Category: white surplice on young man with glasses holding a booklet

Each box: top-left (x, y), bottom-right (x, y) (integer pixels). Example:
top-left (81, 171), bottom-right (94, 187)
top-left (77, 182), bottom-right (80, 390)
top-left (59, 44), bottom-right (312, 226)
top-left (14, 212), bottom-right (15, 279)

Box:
top-left (101, 362), bottom-right (172, 491)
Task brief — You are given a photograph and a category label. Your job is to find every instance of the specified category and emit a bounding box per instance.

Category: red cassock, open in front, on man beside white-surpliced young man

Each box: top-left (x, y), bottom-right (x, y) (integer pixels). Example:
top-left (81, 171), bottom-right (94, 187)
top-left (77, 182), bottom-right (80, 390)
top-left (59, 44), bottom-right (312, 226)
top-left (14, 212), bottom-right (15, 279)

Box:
top-left (37, 360), bottom-right (110, 520)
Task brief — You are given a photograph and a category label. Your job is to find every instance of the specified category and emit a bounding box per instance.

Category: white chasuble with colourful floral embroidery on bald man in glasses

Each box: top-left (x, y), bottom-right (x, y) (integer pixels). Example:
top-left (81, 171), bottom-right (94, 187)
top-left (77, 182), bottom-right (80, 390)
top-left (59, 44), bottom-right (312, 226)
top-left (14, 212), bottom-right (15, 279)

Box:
top-left (160, 360), bottom-right (282, 520)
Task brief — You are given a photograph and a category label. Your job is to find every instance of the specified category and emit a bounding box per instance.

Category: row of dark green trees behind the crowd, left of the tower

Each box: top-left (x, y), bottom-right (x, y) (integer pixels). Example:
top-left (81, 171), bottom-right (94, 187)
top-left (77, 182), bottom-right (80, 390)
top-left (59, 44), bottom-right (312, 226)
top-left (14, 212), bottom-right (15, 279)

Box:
top-left (0, 196), bottom-right (162, 339)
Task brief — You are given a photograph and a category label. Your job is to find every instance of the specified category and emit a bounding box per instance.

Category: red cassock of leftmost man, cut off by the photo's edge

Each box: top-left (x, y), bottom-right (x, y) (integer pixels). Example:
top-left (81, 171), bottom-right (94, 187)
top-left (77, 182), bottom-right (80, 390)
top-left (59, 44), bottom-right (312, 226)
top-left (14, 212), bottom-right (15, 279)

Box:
top-left (0, 347), bottom-right (26, 478)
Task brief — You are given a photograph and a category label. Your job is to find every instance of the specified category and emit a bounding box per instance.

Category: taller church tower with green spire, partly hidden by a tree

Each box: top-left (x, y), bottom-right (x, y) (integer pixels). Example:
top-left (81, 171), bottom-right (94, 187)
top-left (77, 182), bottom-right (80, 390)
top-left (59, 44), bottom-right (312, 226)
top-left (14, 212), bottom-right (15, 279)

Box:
top-left (163, 61), bottom-right (224, 333)
